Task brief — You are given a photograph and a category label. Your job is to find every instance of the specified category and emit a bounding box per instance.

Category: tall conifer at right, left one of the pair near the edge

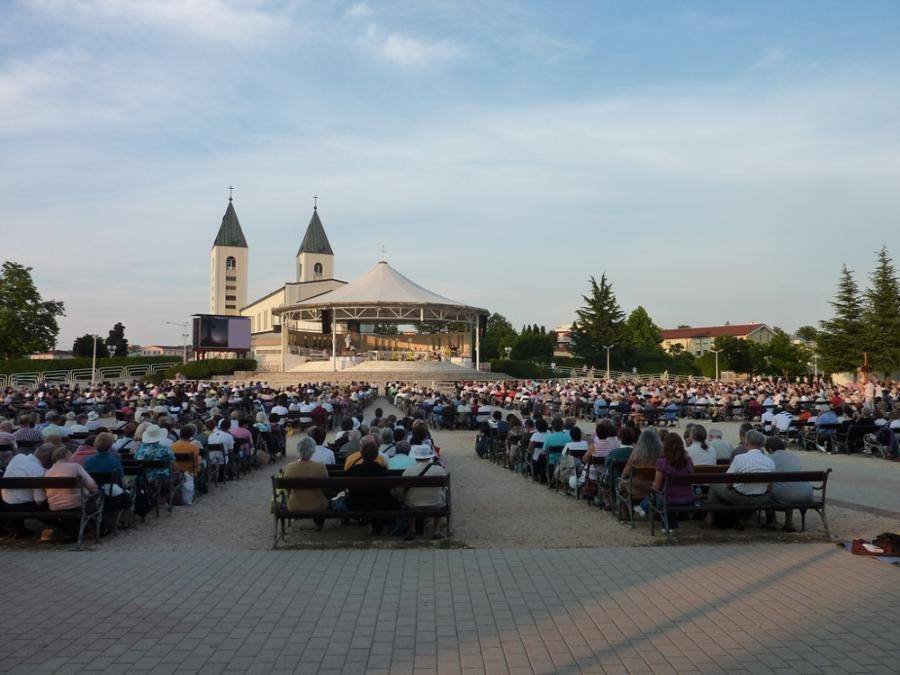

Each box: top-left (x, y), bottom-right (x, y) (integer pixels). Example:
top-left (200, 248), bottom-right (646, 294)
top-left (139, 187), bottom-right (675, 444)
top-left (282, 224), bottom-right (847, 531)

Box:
top-left (816, 265), bottom-right (866, 373)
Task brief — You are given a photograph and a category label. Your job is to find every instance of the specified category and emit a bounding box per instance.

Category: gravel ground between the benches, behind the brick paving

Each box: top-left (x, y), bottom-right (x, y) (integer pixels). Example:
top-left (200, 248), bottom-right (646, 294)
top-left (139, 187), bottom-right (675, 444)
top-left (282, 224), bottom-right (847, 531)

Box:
top-left (0, 399), bottom-right (898, 551)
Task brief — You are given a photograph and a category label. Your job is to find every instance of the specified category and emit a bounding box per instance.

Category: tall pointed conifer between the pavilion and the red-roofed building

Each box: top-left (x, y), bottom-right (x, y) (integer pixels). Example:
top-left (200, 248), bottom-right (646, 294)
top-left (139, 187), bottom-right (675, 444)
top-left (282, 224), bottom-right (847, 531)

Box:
top-left (572, 273), bottom-right (627, 366)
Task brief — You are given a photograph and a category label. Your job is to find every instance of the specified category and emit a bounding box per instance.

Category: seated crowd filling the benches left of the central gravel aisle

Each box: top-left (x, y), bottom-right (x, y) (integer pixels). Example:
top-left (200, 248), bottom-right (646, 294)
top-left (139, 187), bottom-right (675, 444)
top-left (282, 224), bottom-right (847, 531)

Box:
top-left (0, 381), bottom-right (377, 540)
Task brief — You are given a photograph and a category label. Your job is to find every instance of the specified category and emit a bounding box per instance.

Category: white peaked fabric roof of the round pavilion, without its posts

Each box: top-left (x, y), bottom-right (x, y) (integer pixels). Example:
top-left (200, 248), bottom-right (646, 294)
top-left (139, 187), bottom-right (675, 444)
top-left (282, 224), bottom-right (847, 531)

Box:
top-left (297, 261), bottom-right (486, 309)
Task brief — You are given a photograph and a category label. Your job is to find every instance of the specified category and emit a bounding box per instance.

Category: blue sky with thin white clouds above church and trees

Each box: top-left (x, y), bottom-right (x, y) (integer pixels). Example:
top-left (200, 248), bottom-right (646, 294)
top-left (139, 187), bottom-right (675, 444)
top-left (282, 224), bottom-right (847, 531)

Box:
top-left (0, 0), bottom-right (900, 348)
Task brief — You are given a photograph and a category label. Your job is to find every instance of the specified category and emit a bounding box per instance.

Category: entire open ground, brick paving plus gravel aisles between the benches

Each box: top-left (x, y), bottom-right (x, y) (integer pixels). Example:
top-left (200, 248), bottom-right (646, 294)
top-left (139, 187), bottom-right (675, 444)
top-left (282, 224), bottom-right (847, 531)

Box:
top-left (0, 400), bottom-right (900, 673)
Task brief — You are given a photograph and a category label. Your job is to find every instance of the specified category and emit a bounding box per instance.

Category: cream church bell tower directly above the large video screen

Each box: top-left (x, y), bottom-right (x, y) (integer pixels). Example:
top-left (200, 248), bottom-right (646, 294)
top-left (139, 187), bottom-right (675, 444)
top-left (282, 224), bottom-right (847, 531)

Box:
top-left (209, 196), bottom-right (248, 316)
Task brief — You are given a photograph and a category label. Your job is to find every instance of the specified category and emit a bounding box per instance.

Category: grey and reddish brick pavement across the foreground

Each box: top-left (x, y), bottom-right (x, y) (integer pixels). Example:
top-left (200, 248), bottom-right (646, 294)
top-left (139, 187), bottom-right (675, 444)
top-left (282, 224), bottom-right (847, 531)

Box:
top-left (0, 544), bottom-right (900, 673)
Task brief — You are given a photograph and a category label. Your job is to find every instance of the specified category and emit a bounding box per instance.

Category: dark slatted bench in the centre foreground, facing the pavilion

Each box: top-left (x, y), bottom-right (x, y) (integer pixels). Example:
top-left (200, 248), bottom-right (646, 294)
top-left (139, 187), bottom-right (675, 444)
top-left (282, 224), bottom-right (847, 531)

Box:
top-left (272, 475), bottom-right (451, 549)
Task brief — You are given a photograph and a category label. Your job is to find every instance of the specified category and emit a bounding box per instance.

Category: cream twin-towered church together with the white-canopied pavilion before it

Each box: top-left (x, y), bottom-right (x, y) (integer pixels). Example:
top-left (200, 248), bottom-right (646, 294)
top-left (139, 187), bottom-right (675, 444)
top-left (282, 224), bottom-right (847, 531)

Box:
top-left (209, 197), bottom-right (488, 373)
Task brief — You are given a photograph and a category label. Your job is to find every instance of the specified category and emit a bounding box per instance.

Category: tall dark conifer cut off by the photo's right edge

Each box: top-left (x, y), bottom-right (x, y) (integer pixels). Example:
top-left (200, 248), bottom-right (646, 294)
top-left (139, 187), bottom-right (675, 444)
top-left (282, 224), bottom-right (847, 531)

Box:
top-left (863, 247), bottom-right (900, 377)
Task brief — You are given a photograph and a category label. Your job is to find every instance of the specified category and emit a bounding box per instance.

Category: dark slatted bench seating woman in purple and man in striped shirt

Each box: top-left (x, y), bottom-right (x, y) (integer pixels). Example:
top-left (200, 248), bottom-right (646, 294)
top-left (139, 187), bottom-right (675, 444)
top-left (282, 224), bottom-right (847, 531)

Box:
top-left (650, 467), bottom-right (831, 543)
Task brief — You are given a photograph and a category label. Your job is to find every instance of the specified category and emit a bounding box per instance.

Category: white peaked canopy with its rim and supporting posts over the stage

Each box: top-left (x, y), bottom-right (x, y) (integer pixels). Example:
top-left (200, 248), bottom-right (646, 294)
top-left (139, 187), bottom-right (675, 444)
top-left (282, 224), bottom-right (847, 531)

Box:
top-left (273, 261), bottom-right (489, 369)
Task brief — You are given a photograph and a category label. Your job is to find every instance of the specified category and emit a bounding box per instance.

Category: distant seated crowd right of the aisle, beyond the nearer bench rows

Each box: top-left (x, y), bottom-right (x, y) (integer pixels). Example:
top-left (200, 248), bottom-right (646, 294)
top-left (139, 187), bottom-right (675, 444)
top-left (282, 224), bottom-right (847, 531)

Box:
top-left (387, 378), bottom-right (900, 459)
